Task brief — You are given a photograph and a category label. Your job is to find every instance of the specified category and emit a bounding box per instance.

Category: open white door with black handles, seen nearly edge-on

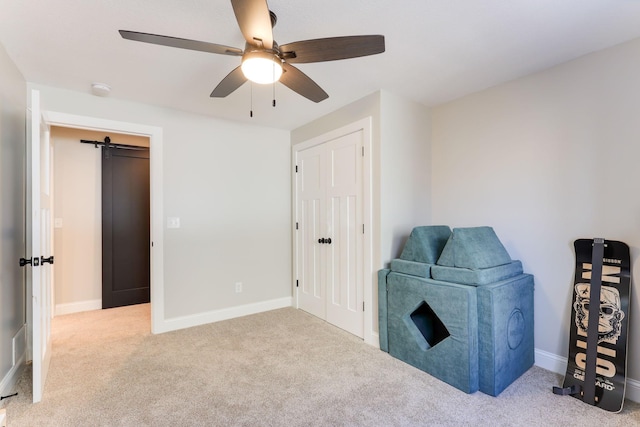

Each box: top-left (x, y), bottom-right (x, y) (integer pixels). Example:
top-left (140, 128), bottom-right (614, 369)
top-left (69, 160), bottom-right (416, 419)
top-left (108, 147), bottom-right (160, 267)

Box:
top-left (27, 90), bottom-right (53, 403)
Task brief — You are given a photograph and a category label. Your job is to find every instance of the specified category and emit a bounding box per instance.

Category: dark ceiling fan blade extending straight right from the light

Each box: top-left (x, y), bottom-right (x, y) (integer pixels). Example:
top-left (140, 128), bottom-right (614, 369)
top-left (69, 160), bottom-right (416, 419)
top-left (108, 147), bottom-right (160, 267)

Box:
top-left (280, 35), bottom-right (385, 64)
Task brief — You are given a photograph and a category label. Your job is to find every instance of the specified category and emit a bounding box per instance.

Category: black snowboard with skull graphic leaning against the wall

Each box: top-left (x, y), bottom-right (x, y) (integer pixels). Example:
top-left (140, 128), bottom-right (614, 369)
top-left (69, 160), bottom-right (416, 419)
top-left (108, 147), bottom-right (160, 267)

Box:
top-left (554, 239), bottom-right (631, 412)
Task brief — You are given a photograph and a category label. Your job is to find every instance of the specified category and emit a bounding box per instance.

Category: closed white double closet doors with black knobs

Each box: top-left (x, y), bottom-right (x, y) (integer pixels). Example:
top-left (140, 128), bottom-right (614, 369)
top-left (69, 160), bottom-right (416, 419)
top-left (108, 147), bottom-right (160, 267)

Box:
top-left (296, 132), bottom-right (364, 338)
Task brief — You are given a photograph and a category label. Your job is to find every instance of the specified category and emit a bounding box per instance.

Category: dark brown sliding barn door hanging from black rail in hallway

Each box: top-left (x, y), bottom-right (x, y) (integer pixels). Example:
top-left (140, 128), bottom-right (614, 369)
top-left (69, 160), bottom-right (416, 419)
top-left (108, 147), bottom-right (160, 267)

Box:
top-left (102, 147), bottom-right (150, 308)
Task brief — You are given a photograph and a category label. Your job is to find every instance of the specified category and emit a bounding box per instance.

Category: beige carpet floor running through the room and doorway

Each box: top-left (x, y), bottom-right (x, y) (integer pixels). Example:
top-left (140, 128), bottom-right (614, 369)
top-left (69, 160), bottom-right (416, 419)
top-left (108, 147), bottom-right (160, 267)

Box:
top-left (1, 305), bottom-right (640, 427)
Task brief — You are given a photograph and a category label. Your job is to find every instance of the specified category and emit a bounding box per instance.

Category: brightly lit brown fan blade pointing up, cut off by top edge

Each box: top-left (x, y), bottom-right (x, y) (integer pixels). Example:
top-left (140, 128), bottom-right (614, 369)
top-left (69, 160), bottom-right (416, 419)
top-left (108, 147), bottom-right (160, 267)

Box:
top-left (231, 0), bottom-right (273, 49)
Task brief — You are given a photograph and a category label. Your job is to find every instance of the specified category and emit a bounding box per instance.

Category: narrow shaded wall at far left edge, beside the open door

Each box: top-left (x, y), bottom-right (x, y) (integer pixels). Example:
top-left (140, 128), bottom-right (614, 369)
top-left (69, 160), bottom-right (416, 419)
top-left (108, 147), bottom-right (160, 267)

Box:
top-left (0, 41), bottom-right (28, 395)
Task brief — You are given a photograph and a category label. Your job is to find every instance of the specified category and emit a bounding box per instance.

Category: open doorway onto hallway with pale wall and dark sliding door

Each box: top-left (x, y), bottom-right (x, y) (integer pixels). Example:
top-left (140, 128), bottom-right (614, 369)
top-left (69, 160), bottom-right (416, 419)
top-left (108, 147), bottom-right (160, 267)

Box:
top-left (51, 126), bottom-right (150, 316)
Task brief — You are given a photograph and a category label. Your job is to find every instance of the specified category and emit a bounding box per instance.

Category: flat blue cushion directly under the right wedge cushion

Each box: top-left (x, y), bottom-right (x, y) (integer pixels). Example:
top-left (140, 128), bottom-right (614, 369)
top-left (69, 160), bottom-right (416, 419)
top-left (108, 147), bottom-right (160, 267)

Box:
top-left (430, 261), bottom-right (522, 286)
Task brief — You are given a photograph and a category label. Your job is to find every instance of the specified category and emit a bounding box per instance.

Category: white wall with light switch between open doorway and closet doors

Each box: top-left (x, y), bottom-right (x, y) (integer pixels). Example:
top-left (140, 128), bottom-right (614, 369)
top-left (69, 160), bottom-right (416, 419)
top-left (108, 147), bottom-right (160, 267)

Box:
top-left (30, 85), bottom-right (291, 326)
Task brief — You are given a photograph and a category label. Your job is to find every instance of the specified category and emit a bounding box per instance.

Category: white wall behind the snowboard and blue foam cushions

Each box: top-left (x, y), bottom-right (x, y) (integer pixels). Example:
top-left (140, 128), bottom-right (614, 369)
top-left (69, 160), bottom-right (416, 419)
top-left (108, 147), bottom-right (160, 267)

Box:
top-left (432, 40), bottom-right (640, 380)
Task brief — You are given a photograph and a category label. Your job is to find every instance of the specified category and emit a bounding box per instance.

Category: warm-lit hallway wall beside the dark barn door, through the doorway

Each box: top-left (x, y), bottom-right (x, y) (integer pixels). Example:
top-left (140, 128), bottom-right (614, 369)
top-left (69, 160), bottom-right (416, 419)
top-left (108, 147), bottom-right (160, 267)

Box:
top-left (51, 127), bottom-right (149, 315)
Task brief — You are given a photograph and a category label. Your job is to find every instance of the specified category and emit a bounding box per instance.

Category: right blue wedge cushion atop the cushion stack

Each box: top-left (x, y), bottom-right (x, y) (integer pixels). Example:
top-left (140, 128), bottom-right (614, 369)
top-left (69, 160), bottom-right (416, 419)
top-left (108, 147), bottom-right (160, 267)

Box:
top-left (437, 227), bottom-right (511, 270)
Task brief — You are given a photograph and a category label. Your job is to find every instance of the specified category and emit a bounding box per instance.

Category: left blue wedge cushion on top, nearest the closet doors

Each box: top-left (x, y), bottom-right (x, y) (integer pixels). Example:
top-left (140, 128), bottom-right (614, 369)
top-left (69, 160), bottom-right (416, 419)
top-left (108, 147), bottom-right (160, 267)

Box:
top-left (400, 225), bottom-right (451, 264)
